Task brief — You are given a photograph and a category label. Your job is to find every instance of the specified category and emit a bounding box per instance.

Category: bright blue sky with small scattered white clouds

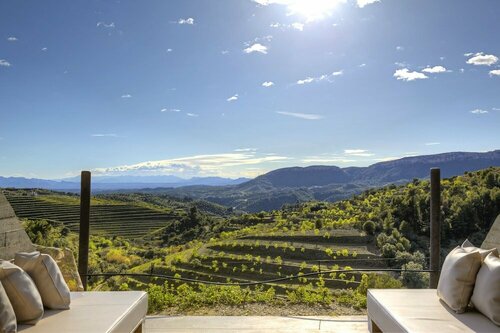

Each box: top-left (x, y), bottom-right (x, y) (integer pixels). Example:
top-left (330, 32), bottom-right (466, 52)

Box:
top-left (0, 0), bottom-right (500, 179)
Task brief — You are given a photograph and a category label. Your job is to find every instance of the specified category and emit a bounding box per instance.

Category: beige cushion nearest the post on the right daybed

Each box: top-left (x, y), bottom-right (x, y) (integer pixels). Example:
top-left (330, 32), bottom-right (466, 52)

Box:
top-left (437, 246), bottom-right (481, 313)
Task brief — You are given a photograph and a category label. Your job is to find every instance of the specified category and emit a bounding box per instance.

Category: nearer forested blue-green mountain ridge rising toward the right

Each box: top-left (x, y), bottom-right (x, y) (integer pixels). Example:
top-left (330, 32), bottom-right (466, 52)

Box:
top-left (153, 150), bottom-right (500, 212)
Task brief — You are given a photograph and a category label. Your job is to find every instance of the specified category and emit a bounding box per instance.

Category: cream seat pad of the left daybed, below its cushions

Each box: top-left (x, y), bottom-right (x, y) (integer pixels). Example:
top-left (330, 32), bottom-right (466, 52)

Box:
top-left (18, 291), bottom-right (148, 333)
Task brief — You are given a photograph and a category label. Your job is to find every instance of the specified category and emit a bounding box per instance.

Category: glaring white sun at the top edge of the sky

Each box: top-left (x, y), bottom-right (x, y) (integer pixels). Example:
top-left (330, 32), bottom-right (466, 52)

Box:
top-left (287, 0), bottom-right (343, 22)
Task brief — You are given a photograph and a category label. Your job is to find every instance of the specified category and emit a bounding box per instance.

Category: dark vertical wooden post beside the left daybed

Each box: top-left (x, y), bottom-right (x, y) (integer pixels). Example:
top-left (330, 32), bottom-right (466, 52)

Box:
top-left (78, 171), bottom-right (90, 290)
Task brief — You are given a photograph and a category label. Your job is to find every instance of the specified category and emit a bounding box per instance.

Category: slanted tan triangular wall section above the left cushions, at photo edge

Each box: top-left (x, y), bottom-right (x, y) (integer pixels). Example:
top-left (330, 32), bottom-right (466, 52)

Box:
top-left (0, 190), bottom-right (34, 260)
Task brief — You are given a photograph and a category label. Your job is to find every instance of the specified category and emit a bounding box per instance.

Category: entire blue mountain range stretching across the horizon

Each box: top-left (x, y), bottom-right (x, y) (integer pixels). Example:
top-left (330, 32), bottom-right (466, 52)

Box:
top-left (0, 150), bottom-right (500, 212)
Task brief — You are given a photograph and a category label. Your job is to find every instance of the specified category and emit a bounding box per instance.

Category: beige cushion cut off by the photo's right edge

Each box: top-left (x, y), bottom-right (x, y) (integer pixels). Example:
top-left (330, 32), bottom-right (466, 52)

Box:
top-left (471, 253), bottom-right (500, 325)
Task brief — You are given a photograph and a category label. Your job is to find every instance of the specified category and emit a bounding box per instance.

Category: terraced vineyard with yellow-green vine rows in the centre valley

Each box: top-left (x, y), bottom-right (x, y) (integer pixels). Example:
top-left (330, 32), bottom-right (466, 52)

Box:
top-left (136, 229), bottom-right (387, 294)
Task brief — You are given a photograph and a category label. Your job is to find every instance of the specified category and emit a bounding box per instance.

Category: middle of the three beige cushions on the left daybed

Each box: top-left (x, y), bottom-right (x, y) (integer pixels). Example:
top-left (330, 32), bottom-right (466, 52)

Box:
top-left (0, 260), bottom-right (43, 325)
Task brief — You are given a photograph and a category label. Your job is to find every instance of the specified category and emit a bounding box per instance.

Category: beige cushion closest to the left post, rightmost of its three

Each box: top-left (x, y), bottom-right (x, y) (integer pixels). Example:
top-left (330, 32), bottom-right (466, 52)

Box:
top-left (14, 251), bottom-right (71, 310)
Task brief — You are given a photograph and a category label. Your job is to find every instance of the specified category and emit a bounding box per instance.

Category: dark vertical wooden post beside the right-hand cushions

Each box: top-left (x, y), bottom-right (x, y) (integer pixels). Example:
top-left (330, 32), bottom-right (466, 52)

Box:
top-left (429, 168), bottom-right (441, 289)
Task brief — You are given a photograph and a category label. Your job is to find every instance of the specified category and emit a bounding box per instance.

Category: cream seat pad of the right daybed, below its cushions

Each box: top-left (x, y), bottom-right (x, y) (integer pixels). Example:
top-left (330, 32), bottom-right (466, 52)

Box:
top-left (367, 289), bottom-right (500, 333)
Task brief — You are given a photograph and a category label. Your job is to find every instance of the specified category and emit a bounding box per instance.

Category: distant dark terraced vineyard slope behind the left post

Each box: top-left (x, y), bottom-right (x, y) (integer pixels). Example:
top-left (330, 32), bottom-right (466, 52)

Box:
top-left (4, 190), bottom-right (184, 238)
